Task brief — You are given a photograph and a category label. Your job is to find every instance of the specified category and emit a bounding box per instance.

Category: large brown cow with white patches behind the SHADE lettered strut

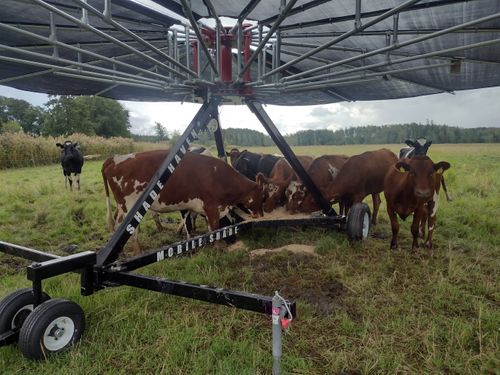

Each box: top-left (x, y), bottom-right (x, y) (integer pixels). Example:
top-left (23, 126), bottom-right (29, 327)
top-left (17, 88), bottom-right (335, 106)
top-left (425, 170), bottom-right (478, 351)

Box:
top-left (101, 150), bottom-right (263, 252)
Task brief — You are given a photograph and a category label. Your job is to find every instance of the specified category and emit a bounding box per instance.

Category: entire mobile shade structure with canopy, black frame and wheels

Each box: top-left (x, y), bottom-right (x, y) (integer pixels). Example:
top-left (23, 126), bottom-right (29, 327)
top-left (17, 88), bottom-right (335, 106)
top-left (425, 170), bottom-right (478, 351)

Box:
top-left (0, 0), bottom-right (500, 373)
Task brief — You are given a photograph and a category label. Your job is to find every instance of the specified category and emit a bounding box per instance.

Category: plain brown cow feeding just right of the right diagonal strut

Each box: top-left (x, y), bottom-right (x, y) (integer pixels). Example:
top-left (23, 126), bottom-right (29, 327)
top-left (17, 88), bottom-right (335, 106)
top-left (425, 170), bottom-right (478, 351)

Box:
top-left (296, 148), bottom-right (397, 225)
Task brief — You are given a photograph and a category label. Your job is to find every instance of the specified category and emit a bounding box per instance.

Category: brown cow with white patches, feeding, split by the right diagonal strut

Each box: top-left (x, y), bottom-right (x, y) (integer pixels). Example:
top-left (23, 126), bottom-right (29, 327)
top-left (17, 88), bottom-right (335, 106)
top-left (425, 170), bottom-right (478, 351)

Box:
top-left (285, 155), bottom-right (349, 213)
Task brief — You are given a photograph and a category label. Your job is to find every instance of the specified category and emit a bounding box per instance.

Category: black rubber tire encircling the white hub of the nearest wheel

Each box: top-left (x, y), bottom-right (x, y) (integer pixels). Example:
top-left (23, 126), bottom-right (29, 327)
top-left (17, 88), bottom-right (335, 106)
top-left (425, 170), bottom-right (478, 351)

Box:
top-left (19, 298), bottom-right (85, 360)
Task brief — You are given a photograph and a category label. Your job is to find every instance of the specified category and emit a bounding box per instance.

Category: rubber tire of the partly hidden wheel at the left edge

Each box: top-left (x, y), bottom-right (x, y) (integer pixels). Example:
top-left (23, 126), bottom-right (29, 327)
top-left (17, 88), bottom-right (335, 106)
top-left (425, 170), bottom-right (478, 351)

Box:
top-left (0, 288), bottom-right (50, 340)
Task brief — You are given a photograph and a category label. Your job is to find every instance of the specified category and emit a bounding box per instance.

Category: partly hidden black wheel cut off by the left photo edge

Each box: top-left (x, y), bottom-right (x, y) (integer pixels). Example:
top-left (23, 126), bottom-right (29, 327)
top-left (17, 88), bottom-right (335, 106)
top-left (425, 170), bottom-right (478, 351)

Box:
top-left (0, 288), bottom-right (50, 340)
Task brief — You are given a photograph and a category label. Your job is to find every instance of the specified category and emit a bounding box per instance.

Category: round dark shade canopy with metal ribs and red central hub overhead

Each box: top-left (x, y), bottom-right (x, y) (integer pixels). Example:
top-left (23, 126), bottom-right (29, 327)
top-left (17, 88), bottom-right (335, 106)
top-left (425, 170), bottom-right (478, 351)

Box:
top-left (0, 0), bottom-right (500, 105)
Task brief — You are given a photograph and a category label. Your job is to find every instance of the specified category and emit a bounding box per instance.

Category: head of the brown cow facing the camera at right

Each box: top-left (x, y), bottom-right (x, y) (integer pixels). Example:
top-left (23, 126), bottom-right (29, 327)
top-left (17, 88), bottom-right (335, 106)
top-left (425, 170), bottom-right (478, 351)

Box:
top-left (395, 156), bottom-right (450, 199)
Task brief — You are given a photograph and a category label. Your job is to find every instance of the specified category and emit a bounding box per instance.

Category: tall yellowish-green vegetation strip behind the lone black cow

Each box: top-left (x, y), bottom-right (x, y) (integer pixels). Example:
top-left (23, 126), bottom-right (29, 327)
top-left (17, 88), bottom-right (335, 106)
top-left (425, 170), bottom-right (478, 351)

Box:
top-left (0, 133), bottom-right (134, 169)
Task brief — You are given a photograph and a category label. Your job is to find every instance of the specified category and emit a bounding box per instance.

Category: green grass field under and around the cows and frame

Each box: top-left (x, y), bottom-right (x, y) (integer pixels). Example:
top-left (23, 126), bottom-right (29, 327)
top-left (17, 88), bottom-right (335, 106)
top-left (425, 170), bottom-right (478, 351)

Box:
top-left (0, 144), bottom-right (500, 375)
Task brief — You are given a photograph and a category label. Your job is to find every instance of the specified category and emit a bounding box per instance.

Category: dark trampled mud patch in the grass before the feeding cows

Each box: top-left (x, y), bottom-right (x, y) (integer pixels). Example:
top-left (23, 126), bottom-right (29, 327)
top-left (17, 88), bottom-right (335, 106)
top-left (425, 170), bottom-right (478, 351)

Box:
top-left (251, 251), bottom-right (348, 315)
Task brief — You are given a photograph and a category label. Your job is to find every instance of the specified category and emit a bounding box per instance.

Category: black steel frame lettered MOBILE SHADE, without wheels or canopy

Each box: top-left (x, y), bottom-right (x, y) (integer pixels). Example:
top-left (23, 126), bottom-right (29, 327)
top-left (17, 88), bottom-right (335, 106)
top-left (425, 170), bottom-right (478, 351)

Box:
top-left (0, 96), bottom-right (367, 366)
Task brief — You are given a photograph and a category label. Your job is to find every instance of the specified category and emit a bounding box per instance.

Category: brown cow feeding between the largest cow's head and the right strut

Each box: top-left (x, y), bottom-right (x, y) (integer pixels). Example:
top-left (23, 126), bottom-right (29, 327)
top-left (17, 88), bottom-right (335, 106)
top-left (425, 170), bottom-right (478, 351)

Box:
top-left (256, 155), bottom-right (314, 212)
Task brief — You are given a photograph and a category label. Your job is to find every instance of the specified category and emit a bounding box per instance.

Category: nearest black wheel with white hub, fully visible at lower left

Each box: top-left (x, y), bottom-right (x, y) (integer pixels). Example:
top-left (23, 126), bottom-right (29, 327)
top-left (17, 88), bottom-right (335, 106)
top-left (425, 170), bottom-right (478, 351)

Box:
top-left (19, 299), bottom-right (85, 359)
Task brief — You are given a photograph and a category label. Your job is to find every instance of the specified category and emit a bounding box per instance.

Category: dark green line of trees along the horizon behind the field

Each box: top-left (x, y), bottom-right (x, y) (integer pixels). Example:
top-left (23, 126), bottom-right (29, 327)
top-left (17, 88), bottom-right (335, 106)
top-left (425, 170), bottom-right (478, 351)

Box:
top-left (0, 96), bottom-right (500, 147)
